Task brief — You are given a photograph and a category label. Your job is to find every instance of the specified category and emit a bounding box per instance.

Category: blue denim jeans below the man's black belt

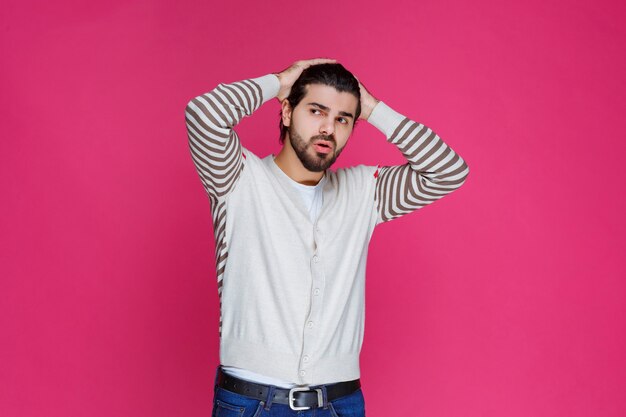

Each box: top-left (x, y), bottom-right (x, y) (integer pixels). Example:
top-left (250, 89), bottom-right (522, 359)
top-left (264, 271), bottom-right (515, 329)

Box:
top-left (211, 367), bottom-right (365, 417)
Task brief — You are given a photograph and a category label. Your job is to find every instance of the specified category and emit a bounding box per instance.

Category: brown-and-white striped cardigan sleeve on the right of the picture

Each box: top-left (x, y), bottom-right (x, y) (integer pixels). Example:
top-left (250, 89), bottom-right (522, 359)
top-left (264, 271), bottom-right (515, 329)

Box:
top-left (367, 101), bottom-right (469, 224)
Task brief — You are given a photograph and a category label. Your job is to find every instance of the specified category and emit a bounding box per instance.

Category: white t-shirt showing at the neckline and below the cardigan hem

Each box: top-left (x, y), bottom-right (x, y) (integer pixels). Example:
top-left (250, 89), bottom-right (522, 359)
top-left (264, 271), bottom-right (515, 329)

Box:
top-left (222, 168), bottom-right (326, 388)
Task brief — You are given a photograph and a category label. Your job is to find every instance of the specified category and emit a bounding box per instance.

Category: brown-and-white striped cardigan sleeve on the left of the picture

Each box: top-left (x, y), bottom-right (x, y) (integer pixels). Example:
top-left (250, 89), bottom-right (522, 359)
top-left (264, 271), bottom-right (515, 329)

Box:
top-left (185, 74), bottom-right (280, 205)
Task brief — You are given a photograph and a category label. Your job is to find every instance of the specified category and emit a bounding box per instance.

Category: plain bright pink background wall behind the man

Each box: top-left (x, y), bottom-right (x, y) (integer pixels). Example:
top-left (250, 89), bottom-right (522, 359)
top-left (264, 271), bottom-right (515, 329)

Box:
top-left (0, 0), bottom-right (626, 417)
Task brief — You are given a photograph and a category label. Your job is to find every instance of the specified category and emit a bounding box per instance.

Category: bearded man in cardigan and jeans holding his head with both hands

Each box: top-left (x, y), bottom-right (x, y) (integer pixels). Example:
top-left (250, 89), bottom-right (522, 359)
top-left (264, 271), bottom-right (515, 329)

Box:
top-left (186, 59), bottom-right (469, 416)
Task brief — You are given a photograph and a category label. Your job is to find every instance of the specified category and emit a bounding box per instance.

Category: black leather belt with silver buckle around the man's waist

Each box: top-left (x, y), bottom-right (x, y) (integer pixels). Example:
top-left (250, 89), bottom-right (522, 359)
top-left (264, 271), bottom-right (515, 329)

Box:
top-left (216, 366), bottom-right (361, 410)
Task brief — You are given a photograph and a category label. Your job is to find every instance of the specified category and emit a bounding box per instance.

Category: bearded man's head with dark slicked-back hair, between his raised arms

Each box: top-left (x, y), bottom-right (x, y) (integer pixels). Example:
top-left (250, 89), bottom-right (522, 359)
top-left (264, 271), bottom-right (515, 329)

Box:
top-left (280, 64), bottom-right (361, 172)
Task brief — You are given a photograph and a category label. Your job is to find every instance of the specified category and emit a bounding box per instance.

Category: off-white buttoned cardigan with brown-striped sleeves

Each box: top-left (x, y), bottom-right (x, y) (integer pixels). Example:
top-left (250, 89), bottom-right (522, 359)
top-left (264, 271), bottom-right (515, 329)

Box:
top-left (186, 74), bottom-right (469, 385)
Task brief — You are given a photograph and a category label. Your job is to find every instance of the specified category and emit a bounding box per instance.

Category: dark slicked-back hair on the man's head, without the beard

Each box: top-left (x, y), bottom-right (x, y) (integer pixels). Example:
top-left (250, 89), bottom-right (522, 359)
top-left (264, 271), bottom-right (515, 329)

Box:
top-left (279, 64), bottom-right (361, 143)
